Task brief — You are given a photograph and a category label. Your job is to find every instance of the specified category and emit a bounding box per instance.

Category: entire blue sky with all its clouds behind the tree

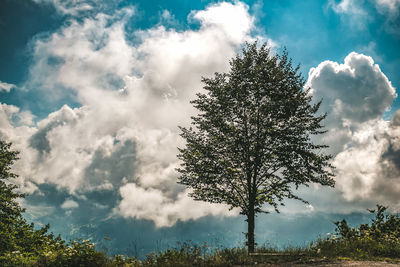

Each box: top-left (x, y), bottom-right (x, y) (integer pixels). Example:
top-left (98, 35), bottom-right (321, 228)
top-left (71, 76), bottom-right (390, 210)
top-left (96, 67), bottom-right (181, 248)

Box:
top-left (0, 0), bottom-right (400, 256)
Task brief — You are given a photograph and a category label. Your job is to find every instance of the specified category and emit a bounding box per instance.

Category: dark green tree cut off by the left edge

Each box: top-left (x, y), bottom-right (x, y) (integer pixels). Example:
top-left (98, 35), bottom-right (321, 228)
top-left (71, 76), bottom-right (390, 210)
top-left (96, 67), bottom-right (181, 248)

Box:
top-left (0, 140), bottom-right (64, 266)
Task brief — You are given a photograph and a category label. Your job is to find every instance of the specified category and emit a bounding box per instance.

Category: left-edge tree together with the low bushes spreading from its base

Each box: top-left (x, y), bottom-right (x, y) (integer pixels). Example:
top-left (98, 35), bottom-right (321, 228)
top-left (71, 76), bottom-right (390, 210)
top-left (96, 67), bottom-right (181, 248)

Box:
top-left (0, 140), bottom-right (108, 266)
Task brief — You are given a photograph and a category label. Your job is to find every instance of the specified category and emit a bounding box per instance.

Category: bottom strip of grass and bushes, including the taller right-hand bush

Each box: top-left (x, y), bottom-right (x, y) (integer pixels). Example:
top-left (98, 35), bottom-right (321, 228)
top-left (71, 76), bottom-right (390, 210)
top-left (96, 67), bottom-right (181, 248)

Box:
top-left (0, 205), bottom-right (400, 267)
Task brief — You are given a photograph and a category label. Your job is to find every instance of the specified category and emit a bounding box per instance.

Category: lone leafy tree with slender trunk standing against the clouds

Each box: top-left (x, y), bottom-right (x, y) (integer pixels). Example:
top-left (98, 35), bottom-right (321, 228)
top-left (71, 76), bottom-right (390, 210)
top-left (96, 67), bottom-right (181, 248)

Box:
top-left (177, 43), bottom-right (334, 253)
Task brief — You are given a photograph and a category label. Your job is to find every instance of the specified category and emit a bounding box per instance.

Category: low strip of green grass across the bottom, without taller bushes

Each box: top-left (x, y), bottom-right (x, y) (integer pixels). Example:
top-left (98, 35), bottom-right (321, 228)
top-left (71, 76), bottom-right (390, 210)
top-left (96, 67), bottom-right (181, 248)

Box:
top-left (1, 238), bottom-right (400, 267)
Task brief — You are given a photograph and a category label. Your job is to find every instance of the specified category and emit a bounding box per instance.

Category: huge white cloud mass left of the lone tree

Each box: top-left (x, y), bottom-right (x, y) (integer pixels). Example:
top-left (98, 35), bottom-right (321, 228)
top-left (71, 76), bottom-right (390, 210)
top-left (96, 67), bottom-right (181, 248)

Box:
top-left (0, 1), bottom-right (253, 226)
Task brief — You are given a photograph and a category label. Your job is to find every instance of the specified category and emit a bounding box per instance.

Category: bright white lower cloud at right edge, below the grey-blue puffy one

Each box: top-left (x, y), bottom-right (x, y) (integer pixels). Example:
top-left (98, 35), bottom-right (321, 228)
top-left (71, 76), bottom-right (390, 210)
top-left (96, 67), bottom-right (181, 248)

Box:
top-left (334, 118), bottom-right (400, 211)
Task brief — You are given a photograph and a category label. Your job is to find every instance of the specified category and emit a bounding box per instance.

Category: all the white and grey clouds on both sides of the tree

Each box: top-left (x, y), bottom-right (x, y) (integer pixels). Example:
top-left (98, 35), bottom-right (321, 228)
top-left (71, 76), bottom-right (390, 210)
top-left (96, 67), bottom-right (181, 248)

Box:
top-left (0, 0), bottom-right (400, 230)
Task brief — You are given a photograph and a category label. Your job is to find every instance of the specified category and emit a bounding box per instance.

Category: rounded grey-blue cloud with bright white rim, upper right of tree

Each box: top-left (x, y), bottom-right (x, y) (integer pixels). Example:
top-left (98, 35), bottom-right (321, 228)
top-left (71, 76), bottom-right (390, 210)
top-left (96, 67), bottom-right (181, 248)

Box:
top-left (307, 52), bottom-right (397, 123)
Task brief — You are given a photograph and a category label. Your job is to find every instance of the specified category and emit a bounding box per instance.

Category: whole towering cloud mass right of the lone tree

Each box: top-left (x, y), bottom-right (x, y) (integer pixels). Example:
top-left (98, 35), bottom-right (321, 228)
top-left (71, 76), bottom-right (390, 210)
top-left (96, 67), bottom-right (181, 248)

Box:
top-left (307, 52), bottom-right (400, 210)
